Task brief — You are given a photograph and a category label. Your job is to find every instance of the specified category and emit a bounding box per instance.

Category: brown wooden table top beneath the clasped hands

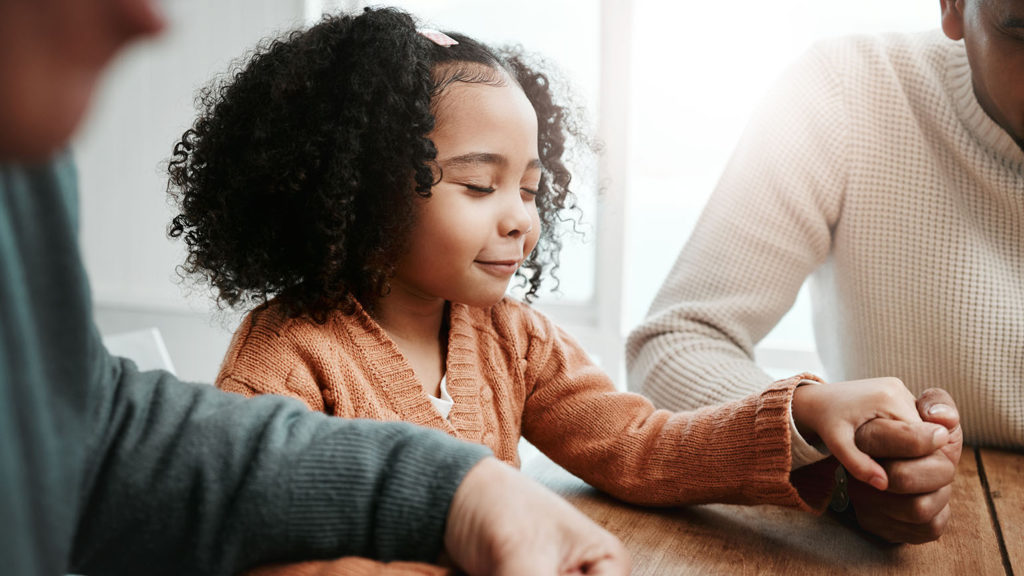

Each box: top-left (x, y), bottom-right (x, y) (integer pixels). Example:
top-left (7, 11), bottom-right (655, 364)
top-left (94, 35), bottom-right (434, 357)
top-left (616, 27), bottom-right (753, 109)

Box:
top-left (523, 447), bottom-right (1024, 576)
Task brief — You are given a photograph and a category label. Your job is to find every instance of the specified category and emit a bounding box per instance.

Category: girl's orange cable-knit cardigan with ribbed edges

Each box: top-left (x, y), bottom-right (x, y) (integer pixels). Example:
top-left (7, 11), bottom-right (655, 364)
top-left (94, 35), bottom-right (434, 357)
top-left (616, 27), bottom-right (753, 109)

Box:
top-left (217, 298), bottom-right (831, 569)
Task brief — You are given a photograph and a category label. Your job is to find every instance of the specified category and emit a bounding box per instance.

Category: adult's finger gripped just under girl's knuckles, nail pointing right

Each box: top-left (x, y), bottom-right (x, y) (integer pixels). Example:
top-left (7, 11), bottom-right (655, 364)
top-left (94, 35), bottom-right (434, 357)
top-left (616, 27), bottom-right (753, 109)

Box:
top-left (854, 418), bottom-right (949, 458)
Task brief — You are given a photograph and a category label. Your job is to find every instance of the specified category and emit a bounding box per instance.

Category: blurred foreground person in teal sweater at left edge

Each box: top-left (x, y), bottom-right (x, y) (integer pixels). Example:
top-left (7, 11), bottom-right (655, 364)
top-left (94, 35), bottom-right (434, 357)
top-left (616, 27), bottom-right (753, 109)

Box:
top-left (0, 0), bottom-right (629, 575)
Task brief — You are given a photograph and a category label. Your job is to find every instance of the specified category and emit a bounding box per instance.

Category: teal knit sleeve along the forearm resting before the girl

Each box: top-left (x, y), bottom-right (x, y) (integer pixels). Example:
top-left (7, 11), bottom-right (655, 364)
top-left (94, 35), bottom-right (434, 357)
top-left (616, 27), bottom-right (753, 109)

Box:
top-left (73, 325), bottom-right (487, 575)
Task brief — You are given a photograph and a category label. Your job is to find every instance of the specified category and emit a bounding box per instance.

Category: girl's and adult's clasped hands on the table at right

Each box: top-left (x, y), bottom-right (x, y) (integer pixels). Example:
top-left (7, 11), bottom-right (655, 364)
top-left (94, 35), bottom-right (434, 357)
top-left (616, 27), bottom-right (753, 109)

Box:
top-left (793, 378), bottom-right (964, 543)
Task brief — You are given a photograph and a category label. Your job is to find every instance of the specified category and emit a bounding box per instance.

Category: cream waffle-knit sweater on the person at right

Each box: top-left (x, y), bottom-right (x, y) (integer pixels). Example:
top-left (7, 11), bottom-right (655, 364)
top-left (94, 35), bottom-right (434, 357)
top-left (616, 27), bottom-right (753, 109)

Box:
top-left (627, 33), bottom-right (1024, 448)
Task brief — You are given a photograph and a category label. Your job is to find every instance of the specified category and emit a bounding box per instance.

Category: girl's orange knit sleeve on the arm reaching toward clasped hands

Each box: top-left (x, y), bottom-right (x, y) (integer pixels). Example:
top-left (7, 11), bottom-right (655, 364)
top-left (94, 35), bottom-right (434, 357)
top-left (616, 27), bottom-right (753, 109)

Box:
top-left (522, 311), bottom-right (831, 510)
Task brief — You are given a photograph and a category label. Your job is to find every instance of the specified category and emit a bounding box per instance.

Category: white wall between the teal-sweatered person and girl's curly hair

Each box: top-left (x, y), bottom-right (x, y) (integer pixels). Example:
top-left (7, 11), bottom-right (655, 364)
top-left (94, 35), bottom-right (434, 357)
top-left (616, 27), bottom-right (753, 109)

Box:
top-left (74, 0), bottom-right (305, 381)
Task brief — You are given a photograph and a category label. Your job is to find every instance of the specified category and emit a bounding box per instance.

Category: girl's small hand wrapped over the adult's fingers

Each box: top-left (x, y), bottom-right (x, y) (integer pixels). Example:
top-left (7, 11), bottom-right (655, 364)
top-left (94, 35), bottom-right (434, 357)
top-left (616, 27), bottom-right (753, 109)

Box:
top-left (793, 378), bottom-right (949, 490)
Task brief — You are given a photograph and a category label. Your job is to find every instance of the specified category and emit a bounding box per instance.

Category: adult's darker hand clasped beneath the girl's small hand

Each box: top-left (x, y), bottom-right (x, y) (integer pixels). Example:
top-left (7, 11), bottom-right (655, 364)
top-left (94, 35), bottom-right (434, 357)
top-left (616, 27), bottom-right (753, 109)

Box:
top-left (849, 388), bottom-right (964, 544)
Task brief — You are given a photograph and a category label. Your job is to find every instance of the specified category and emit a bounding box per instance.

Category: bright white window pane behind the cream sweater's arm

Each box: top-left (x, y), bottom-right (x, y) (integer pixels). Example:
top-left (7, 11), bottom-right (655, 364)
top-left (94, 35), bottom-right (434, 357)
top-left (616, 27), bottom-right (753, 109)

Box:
top-left (623, 0), bottom-right (939, 373)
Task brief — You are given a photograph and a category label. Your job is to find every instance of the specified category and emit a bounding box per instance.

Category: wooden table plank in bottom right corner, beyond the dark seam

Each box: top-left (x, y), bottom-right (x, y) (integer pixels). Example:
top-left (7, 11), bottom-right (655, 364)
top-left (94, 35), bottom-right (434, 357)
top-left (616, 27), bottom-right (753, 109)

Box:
top-left (981, 449), bottom-right (1024, 574)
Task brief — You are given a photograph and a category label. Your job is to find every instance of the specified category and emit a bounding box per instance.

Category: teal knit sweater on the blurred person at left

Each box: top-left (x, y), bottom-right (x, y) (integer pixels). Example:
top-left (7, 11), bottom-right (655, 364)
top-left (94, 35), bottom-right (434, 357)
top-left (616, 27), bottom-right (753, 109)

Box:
top-left (0, 153), bottom-right (487, 575)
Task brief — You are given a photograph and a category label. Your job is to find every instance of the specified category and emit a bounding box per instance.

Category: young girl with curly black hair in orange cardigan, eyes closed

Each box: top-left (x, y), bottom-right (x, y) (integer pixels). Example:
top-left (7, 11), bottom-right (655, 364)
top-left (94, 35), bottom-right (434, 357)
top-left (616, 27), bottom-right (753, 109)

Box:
top-left (170, 9), bottom-right (941, 562)
